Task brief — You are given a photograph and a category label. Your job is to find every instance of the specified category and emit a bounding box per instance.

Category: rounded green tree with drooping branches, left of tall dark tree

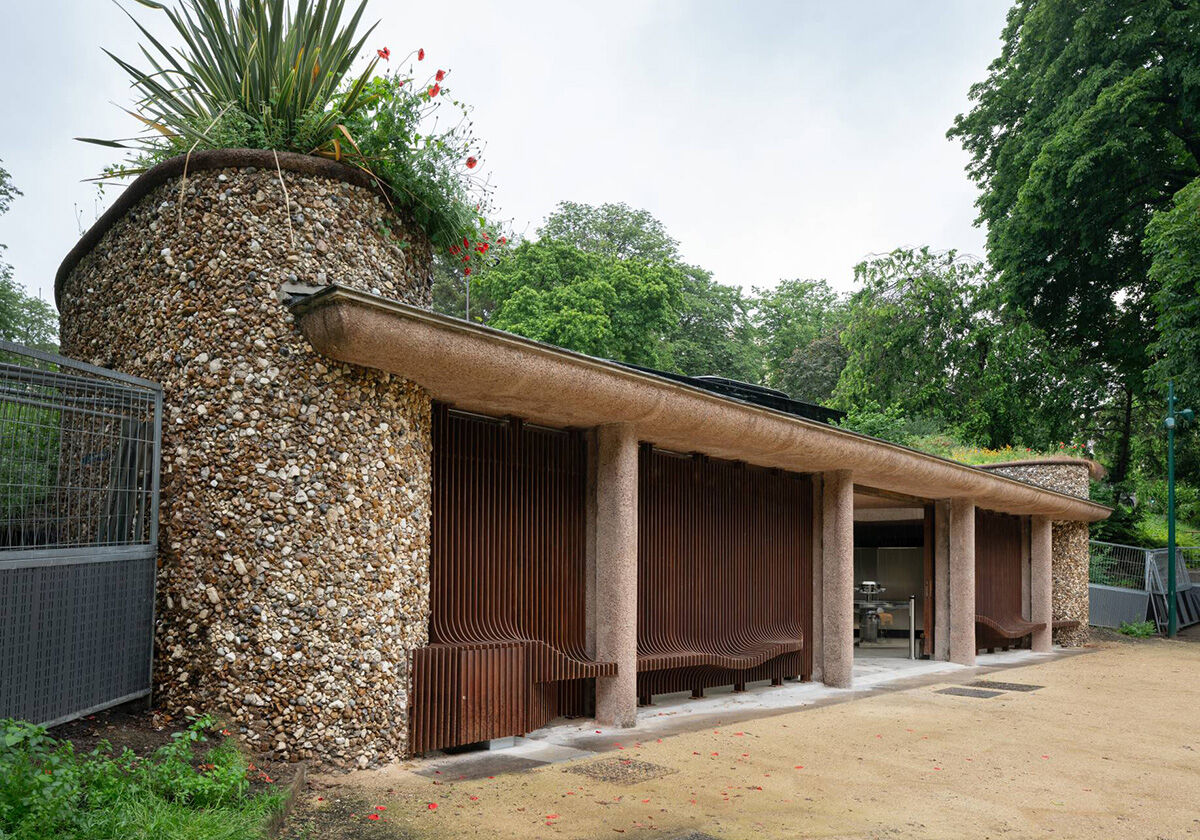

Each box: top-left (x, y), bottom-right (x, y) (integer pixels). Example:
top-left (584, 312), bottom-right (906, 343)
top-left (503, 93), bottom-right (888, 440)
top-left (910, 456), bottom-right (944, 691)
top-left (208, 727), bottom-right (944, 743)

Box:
top-left (834, 247), bottom-right (1081, 446)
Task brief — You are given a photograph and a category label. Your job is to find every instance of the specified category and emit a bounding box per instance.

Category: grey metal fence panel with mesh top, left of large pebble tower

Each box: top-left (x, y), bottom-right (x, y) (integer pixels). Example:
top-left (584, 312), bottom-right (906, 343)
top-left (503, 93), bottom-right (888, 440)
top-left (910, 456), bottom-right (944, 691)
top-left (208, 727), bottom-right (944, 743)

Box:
top-left (0, 341), bottom-right (162, 725)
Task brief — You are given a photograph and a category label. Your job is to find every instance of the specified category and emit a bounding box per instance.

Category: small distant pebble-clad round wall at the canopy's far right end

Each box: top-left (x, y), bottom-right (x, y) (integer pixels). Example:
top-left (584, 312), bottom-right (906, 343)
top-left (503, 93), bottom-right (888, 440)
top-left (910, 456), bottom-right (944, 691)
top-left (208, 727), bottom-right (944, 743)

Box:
top-left (988, 460), bottom-right (1091, 647)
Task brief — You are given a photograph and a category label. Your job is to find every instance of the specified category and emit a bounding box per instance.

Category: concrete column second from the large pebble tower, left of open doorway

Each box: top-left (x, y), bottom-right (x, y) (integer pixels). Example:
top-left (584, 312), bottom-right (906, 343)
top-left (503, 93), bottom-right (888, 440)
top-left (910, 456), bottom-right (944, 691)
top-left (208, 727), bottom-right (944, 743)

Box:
top-left (821, 469), bottom-right (854, 689)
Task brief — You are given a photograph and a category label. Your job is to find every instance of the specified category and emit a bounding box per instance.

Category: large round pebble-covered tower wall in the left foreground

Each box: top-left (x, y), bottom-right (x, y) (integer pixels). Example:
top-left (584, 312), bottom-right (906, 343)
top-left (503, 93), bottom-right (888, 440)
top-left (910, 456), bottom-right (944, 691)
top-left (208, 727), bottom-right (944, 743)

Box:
top-left (59, 152), bottom-right (431, 767)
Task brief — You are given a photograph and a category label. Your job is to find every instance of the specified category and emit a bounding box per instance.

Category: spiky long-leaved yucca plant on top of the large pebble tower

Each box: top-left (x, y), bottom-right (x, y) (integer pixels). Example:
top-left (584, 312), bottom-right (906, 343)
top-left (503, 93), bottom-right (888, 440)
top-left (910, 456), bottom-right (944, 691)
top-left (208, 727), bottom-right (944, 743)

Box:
top-left (79, 0), bottom-right (378, 169)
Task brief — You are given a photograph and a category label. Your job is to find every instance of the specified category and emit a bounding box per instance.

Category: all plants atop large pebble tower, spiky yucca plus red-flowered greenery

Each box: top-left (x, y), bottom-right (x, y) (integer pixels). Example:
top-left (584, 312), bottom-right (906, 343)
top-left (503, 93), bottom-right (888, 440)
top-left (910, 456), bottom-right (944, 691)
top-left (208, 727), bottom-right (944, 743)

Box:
top-left (80, 0), bottom-right (497, 255)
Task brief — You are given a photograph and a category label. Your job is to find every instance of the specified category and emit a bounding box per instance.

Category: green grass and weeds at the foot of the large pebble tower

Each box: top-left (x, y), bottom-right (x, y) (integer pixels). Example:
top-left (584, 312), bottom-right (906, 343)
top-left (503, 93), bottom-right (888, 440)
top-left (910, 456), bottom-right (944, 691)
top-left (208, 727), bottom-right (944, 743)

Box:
top-left (0, 716), bottom-right (284, 840)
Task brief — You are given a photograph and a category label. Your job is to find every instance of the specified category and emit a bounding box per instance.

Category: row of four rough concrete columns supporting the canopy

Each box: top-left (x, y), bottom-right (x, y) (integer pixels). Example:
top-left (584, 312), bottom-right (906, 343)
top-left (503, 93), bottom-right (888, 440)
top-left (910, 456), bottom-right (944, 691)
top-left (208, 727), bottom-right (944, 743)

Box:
top-left (592, 436), bottom-right (1052, 726)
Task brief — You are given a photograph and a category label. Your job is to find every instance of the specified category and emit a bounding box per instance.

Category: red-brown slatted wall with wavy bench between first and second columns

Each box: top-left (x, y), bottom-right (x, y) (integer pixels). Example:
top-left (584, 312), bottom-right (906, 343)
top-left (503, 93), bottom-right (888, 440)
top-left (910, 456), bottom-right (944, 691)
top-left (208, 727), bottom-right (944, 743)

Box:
top-left (637, 445), bottom-right (812, 702)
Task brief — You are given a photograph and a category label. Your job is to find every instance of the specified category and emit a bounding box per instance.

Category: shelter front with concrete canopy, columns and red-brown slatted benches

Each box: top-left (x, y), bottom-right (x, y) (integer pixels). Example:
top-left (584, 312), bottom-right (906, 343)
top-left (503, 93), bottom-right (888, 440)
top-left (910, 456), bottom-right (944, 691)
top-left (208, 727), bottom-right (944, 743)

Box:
top-left (290, 287), bottom-right (1109, 752)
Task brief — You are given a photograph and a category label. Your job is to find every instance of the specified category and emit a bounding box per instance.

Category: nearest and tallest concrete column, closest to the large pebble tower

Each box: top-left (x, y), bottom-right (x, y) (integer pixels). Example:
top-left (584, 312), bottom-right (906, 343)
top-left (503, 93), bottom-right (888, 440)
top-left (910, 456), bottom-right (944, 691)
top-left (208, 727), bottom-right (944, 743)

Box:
top-left (595, 424), bottom-right (637, 726)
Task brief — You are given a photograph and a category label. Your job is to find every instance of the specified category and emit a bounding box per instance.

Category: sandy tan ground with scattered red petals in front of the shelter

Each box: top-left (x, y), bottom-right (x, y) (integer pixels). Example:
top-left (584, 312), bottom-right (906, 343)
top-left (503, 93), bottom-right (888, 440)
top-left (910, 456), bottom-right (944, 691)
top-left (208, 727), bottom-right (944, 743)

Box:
top-left (286, 640), bottom-right (1200, 840)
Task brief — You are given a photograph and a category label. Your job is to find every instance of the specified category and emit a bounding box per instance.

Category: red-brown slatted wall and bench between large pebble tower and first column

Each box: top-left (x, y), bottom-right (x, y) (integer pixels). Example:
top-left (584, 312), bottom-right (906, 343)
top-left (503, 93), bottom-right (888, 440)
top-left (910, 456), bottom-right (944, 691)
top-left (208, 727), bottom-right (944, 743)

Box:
top-left (409, 404), bottom-right (616, 752)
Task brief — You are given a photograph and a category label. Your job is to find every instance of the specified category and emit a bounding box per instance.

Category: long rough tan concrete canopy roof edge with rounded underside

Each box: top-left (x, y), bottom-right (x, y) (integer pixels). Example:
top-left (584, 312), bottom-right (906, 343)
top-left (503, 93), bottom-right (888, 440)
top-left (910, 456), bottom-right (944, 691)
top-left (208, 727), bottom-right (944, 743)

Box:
top-left (290, 286), bottom-right (1111, 522)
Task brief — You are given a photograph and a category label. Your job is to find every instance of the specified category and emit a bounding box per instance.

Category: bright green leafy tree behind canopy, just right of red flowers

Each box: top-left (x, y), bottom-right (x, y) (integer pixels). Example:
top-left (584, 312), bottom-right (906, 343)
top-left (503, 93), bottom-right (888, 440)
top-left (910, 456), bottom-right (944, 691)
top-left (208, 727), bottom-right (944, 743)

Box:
top-left (472, 240), bottom-right (683, 366)
